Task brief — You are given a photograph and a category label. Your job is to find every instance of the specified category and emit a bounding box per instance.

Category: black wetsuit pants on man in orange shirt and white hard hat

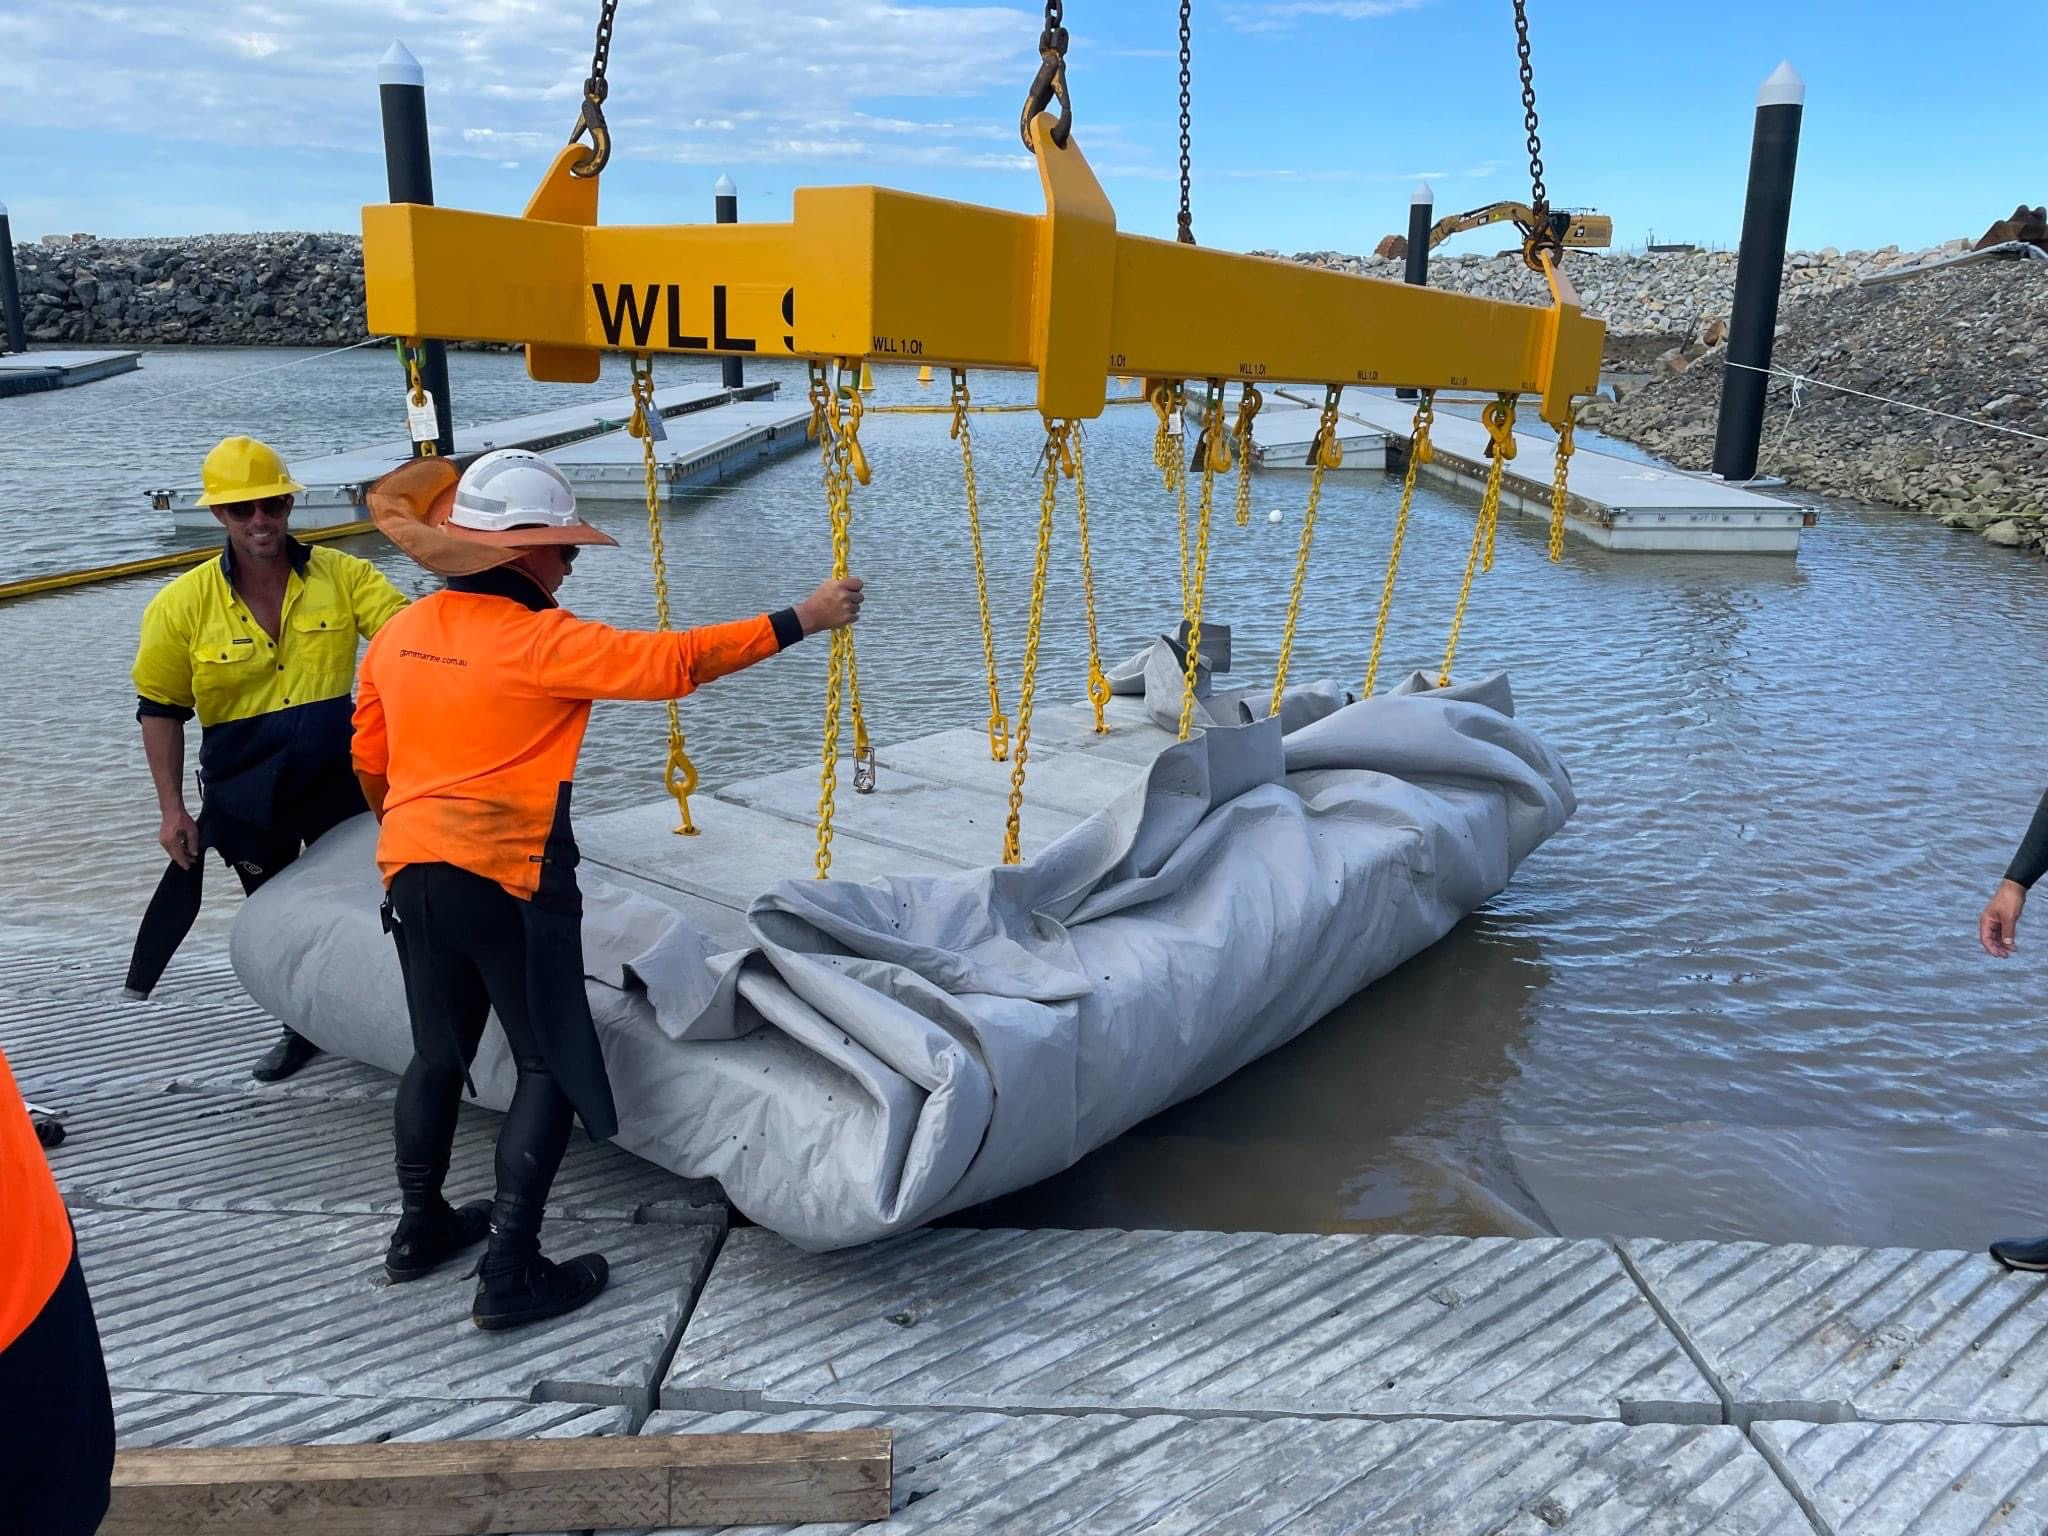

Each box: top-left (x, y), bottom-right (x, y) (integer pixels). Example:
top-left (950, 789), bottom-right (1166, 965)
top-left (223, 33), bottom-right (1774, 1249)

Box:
top-left (391, 864), bottom-right (571, 1268)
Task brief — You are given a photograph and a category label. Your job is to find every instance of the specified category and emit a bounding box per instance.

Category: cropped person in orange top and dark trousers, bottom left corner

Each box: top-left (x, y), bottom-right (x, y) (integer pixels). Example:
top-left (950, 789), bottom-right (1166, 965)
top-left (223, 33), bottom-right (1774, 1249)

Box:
top-left (0, 1055), bottom-right (115, 1536)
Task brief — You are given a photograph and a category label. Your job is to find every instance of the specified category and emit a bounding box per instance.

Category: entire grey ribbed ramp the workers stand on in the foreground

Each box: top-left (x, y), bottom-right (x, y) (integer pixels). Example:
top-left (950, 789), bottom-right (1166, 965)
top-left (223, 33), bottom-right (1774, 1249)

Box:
top-left (12, 913), bottom-right (2048, 1536)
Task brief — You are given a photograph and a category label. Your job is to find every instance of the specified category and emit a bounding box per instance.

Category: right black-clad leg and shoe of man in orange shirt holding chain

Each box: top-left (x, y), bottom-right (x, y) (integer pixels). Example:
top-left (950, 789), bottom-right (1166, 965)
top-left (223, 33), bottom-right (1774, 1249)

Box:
top-left (436, 870), bottom-right (610, 1329)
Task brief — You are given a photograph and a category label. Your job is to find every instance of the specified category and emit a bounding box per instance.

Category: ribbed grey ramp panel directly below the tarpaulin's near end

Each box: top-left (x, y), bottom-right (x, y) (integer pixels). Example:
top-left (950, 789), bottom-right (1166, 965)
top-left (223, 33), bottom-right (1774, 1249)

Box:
top-left (662, 1229), bottom-right (1720, 1423)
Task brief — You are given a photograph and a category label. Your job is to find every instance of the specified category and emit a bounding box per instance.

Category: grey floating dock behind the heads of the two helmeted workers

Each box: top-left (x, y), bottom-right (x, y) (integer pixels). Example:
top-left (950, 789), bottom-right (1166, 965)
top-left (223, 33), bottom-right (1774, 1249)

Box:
top-left (150, 381), bottom-right (809, 528)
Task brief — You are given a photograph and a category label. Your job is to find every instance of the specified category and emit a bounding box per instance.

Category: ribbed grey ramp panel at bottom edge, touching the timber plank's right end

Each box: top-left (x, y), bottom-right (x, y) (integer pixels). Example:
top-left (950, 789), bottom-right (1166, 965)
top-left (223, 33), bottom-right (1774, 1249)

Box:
top-left (622, 1409), bottom-right (1810, 1536)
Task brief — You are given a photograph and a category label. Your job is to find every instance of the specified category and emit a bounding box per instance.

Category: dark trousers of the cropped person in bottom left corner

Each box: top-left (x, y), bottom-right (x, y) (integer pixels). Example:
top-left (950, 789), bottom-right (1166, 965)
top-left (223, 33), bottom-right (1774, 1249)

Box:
top-left (0, 1253), bottom-right (115, 1536)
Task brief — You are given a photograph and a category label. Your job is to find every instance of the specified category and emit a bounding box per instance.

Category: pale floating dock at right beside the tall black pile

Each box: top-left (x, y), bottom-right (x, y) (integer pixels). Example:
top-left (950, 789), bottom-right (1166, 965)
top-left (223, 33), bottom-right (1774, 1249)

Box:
top-left (1343, 389), bottom-right (1815, 555)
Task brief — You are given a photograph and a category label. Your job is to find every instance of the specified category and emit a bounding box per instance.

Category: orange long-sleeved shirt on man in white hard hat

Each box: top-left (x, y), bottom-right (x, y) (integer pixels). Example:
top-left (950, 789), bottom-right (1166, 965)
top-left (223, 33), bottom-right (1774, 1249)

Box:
top-left (354, 575), bottom-right (801, 897)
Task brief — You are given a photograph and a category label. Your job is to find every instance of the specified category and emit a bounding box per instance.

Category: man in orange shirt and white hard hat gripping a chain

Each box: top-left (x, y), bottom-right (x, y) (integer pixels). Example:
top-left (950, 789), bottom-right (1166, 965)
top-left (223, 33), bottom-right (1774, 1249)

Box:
top-left (354, 449), bottom-right (862, 1329)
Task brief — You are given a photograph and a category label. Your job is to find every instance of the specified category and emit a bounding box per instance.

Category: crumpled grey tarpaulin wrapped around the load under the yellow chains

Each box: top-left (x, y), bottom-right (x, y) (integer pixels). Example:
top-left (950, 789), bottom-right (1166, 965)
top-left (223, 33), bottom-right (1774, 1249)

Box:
top-left (233, 647), bottom-right (1573, 1249)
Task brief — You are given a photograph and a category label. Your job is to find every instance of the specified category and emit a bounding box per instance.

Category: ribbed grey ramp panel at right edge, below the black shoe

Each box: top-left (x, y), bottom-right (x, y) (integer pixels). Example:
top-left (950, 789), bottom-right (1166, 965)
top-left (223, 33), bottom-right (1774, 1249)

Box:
top-left (1622, 1239), bottom-right (2048, 1423)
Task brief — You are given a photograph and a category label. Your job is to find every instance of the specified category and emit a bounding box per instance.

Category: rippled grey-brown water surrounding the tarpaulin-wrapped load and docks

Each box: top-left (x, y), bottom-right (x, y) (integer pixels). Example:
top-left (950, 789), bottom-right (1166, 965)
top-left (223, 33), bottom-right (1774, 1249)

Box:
top-left (0, 352), bottom-right (2048, 1245)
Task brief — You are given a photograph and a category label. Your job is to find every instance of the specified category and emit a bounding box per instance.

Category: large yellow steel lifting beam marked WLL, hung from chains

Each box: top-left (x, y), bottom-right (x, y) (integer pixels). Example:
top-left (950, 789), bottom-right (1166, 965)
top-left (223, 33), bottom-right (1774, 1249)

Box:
top-left (362, 115), bottom-right (1606, 424)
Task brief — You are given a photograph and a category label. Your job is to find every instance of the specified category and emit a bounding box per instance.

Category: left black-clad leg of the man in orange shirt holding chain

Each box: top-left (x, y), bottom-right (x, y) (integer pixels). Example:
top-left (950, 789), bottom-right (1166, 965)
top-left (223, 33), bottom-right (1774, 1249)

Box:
top-left (385, 864), bottom-right (489, 1282)
